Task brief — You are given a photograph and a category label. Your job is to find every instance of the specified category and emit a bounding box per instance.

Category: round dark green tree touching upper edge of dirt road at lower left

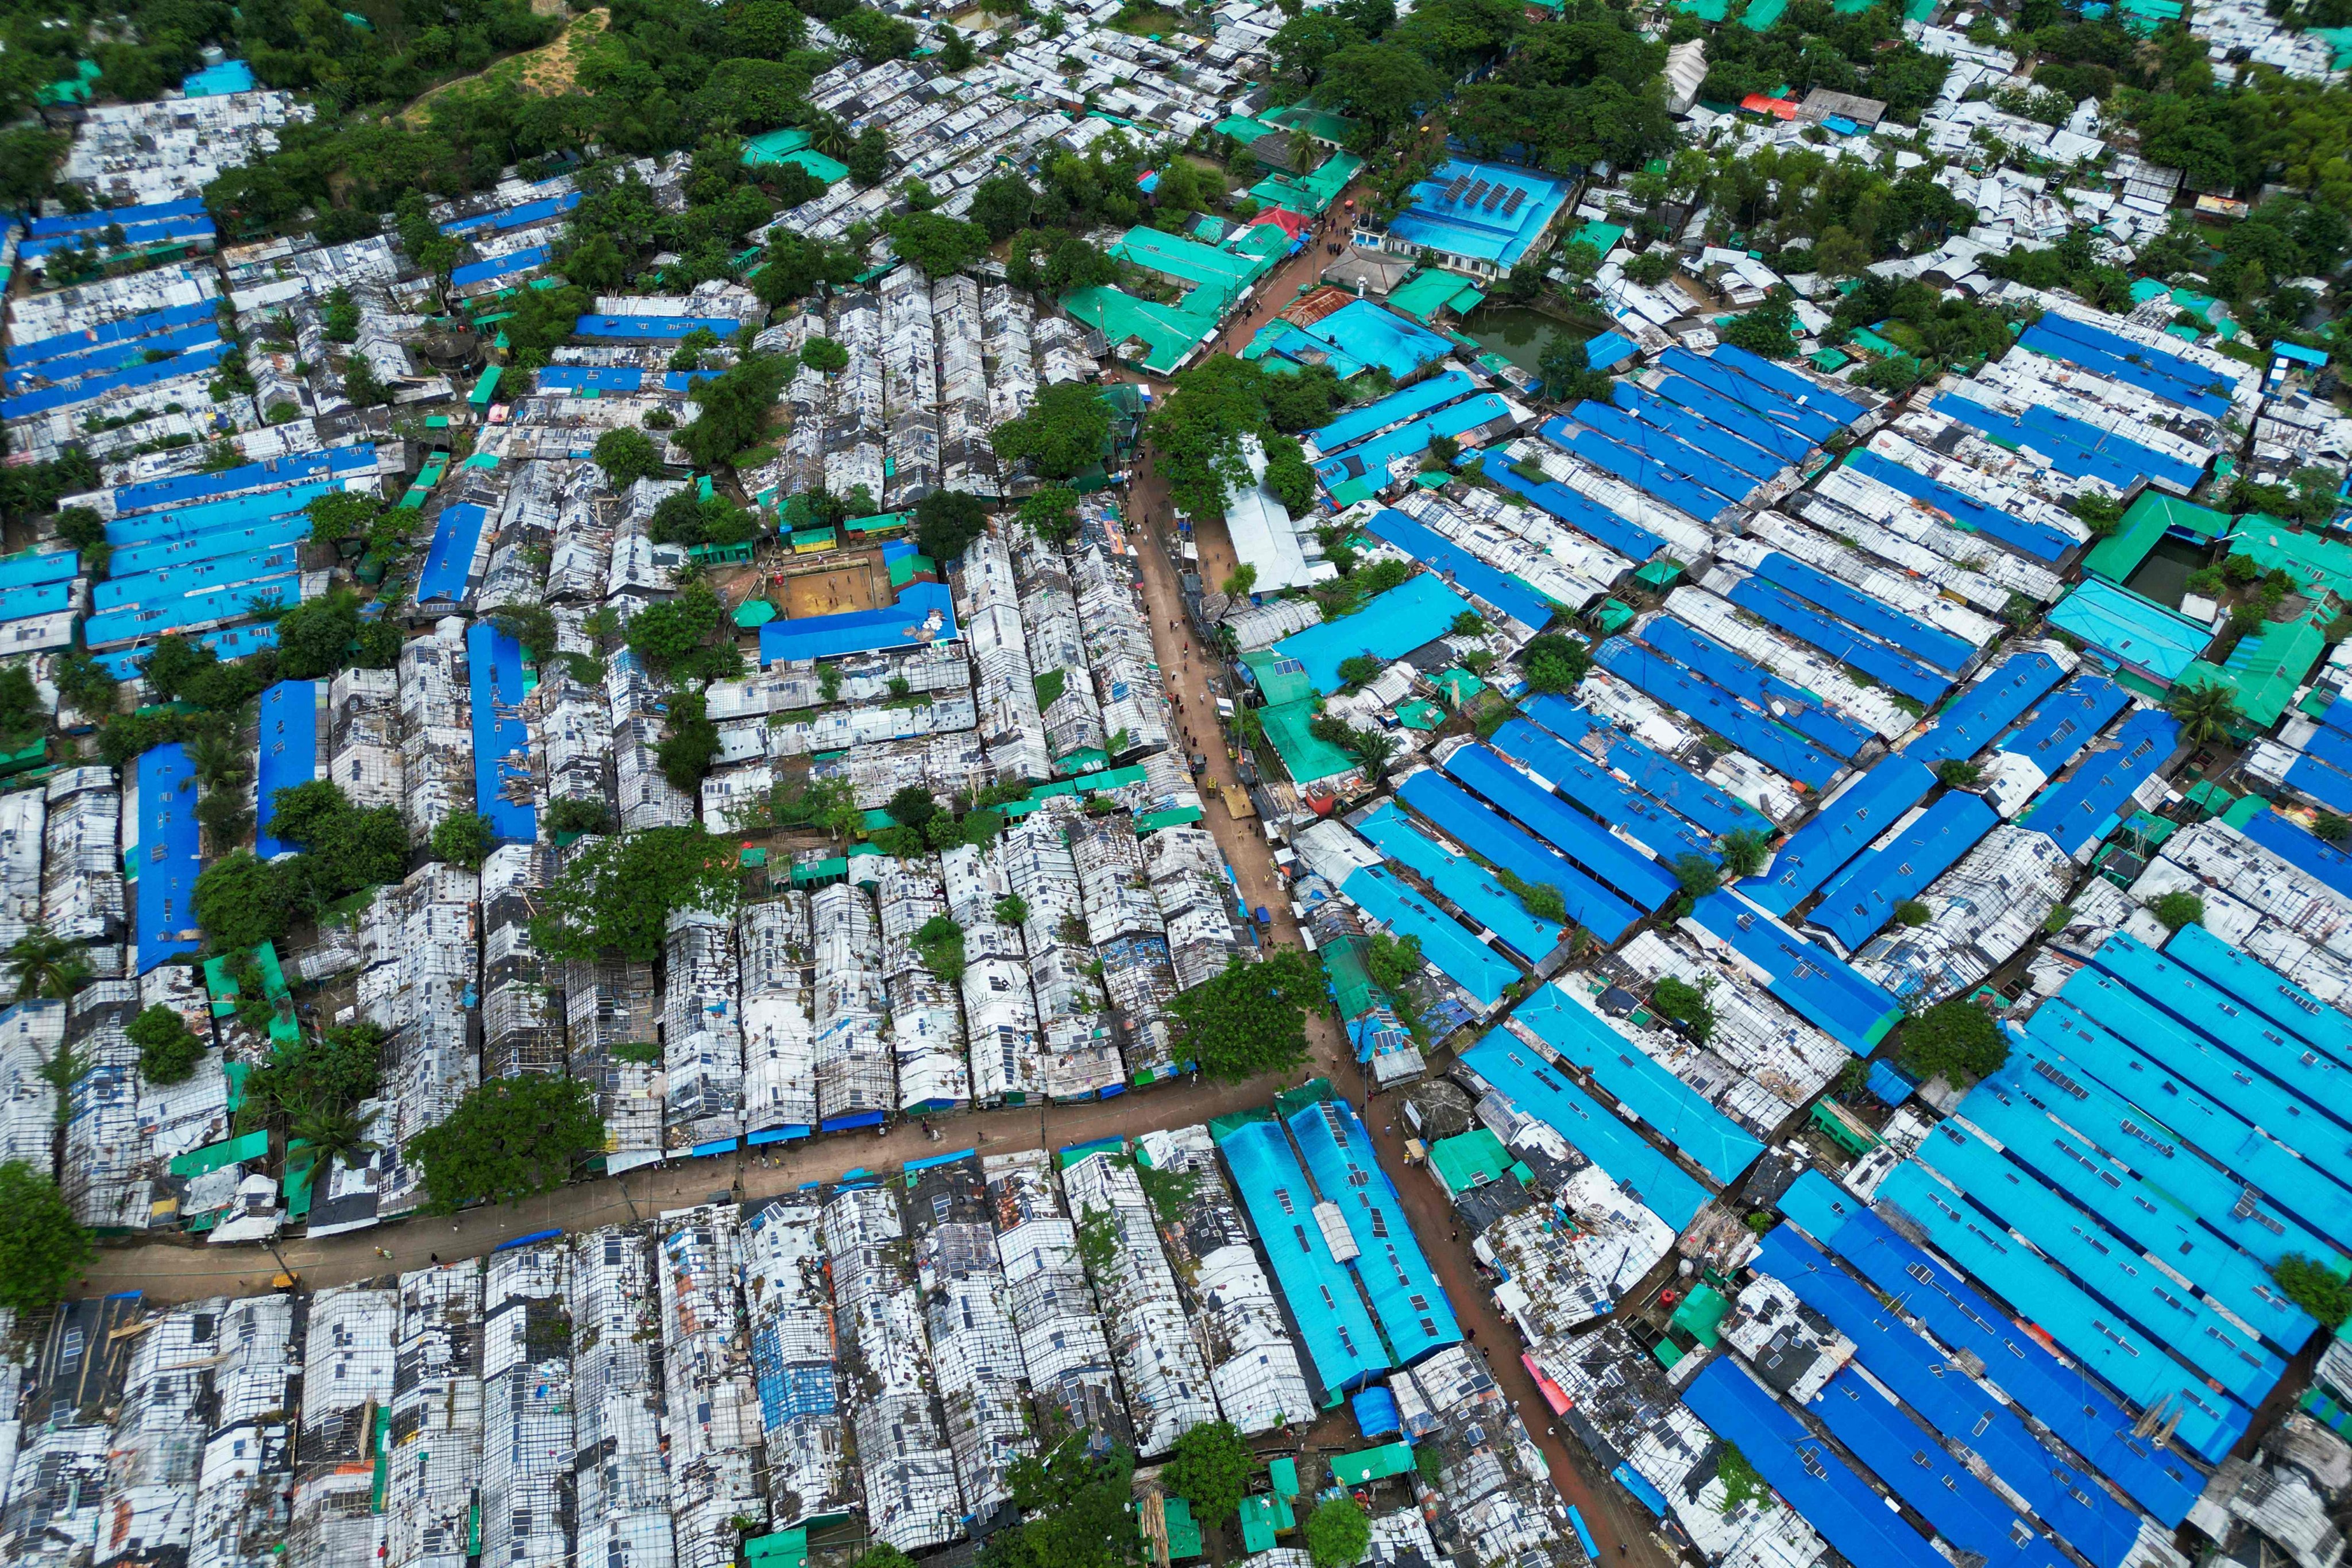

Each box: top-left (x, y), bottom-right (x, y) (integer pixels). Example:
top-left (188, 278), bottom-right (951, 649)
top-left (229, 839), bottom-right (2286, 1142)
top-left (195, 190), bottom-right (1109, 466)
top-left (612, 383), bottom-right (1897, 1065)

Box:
top-left (407, 1072), bottom-right (604, 1213)
